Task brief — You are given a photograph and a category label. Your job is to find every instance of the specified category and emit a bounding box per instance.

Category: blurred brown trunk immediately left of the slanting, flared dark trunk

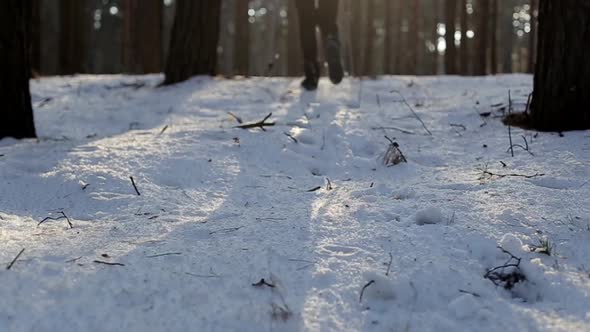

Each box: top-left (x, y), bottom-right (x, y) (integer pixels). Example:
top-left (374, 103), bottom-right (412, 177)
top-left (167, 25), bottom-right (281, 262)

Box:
top-left (123, 0), bottom-right (163, 74)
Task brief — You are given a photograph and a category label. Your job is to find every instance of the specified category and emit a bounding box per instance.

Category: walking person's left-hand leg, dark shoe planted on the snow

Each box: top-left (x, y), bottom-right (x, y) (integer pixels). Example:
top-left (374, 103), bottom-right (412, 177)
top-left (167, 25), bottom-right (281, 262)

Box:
top-left (296, 0), bottom-right (320, 90)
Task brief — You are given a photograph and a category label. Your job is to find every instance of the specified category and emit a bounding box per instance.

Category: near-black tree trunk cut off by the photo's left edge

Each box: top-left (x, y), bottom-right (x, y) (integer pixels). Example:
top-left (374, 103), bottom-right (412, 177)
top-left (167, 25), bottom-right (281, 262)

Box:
top-left (0, 0), bottom-right (36, 139)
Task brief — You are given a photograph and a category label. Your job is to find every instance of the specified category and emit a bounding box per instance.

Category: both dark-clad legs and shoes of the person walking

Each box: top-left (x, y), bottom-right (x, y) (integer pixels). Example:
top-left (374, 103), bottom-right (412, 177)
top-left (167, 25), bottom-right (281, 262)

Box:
top-left (296, 0), bottom-right (344, 90)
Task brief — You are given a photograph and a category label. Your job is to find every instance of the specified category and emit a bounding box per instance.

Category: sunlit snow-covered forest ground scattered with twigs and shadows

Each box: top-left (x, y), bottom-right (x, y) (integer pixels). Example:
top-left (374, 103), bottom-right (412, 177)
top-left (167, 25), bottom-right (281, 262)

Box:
top-left (0, 76), bottom-right (590, 331)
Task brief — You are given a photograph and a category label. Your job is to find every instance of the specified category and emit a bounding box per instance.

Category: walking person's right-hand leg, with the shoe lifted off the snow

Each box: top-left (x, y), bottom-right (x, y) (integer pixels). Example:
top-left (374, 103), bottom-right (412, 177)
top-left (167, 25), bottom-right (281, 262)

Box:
top-left (317, 0), bottom-right (344, 84)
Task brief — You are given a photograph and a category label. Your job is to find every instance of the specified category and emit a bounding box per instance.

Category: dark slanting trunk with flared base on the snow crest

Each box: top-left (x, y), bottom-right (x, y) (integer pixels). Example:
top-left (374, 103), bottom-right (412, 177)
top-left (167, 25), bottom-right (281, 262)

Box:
top-left (164, 0), bottom-right (221, 84)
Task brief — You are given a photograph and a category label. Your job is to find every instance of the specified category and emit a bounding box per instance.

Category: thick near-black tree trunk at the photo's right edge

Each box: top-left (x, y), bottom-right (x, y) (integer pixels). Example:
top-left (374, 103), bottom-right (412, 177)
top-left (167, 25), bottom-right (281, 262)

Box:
top-left (531, 0), bottom-right (590, 131)
